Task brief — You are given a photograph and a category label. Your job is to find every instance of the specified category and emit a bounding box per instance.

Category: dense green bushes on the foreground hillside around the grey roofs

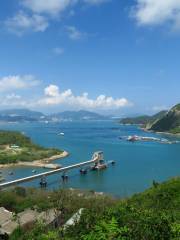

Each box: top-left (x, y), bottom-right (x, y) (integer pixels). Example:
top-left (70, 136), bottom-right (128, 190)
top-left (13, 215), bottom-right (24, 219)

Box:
top-left (0, 178), bottom-right (180, 240)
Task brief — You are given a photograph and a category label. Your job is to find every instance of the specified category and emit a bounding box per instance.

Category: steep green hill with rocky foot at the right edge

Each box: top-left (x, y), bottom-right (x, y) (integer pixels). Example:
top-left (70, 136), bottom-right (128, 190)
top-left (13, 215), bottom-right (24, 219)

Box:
top-left (147, 104), bottom-right (180, 134)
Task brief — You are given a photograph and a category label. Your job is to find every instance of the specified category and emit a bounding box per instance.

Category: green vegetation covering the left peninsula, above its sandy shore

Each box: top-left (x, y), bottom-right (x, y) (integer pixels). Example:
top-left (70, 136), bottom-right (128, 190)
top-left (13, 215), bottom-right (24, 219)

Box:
top-left (0, 131), bottom-right (62, 164)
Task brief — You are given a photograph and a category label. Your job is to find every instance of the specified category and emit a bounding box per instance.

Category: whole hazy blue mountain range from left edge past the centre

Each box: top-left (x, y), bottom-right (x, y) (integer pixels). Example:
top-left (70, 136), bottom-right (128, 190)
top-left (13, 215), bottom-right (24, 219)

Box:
top-left (0, 109), bottom-right (111, 122)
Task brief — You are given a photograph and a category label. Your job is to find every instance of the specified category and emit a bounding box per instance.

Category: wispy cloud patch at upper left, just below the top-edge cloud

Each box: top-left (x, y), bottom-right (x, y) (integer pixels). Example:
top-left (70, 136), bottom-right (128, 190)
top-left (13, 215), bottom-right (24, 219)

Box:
top-left (5, 11), bottom-right (49, 36)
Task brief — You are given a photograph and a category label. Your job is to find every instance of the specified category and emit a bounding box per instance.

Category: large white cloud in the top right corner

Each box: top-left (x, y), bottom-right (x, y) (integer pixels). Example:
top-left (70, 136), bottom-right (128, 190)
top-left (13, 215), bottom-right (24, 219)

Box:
top-left (133, 0), bottom-right (180, 28)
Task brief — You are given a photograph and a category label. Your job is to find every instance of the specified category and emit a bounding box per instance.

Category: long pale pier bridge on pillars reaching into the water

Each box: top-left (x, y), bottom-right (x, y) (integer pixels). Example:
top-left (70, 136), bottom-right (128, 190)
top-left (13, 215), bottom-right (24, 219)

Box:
top-left (0, 151), bottom-right (104, 190)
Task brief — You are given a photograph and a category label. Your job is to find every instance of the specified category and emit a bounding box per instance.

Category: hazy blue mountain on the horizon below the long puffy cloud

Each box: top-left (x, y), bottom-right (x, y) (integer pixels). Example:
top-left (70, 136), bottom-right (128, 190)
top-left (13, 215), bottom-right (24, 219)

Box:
top-left (50, 110), bottom-right (109, 121)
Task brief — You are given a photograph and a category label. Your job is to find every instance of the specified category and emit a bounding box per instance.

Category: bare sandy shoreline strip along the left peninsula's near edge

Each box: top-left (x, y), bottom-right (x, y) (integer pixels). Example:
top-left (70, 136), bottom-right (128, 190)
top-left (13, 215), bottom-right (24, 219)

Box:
top-left (0, 151), bottom-right (69, 169)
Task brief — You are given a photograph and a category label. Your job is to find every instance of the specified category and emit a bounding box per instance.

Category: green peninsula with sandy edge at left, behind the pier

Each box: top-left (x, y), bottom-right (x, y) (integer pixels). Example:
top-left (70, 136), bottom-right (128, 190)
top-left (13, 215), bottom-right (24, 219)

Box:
top-left (0, 131), bottom-right (68, 168)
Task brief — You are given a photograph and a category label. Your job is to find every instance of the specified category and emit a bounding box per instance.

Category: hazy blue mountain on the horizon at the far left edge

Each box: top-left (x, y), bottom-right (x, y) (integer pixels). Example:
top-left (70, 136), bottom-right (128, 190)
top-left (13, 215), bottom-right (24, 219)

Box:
top-left (0, 109), bottom-right (45, 122)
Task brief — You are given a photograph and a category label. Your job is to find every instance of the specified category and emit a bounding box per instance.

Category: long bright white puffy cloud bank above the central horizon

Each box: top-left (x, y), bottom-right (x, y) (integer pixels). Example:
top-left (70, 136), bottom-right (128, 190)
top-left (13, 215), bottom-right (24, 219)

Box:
top-left (38, 85), bottom-right (132, 109)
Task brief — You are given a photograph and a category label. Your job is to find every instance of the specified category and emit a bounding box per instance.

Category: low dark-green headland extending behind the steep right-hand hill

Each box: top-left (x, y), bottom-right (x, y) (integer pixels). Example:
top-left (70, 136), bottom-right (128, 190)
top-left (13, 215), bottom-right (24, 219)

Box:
top-left (120, 111), bottom-right (167, 125)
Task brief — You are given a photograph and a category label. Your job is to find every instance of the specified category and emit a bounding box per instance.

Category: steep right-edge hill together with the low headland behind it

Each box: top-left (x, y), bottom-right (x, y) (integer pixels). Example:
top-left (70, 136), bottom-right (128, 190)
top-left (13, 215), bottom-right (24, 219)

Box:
top-left (120, 104), bottom-right (180, 134)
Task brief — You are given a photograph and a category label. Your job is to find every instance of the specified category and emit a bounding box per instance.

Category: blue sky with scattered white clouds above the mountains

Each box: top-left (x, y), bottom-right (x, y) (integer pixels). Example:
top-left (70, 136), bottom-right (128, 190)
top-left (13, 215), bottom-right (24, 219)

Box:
top-left (0, 0), bottom-right (180, 116)
